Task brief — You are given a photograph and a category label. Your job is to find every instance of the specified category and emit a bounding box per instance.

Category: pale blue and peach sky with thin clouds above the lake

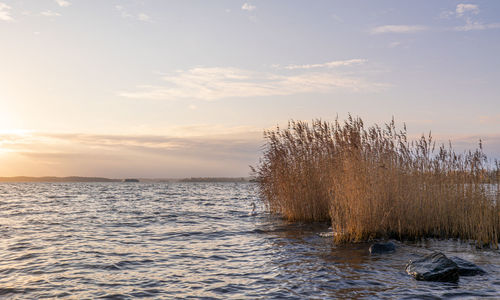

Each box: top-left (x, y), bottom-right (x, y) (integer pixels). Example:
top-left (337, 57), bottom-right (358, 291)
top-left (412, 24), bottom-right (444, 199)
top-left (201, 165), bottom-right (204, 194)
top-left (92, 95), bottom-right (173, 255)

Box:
top-left (0, 0), bottom-right (500, 178)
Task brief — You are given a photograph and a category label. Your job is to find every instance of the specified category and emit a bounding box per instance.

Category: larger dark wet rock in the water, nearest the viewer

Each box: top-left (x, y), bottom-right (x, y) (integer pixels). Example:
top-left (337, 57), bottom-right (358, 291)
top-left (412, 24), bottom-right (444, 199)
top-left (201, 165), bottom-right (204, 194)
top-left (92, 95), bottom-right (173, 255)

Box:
top-left (406, 252), bottom-right (459, 282)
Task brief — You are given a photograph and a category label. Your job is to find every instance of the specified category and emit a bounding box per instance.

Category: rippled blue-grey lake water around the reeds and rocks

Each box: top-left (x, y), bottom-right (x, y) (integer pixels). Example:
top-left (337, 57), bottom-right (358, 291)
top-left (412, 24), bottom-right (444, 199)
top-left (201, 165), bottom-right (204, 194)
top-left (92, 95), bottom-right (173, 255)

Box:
top-left (0, 183), bottom-right (500, 299)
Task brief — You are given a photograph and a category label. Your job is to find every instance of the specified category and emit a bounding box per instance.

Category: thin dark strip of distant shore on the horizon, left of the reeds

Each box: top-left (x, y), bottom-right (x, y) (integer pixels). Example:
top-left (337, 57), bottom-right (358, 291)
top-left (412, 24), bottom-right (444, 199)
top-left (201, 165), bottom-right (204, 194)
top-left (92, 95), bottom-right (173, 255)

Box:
top-left (0, 176), bottom-right (252, 183)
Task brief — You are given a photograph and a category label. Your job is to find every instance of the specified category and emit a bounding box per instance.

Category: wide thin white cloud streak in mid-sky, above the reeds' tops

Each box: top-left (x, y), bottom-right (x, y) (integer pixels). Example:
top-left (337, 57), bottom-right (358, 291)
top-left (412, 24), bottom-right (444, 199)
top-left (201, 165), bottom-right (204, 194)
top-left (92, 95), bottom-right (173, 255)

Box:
top-left (119, 64), bottom-right (387, 100)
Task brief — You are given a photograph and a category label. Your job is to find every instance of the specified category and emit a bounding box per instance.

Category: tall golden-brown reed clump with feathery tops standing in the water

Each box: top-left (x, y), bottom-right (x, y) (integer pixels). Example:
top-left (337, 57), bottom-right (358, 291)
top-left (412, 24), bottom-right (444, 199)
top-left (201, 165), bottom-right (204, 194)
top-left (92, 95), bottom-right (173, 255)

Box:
top-left (254, 116), bottom-right (500, 246)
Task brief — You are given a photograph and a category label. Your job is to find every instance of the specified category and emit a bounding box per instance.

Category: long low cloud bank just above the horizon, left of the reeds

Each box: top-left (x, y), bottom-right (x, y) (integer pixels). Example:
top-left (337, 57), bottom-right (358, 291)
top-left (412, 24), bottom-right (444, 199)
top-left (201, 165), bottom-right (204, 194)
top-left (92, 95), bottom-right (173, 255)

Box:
top-left (0, 130), bottom-right (262, 177)
